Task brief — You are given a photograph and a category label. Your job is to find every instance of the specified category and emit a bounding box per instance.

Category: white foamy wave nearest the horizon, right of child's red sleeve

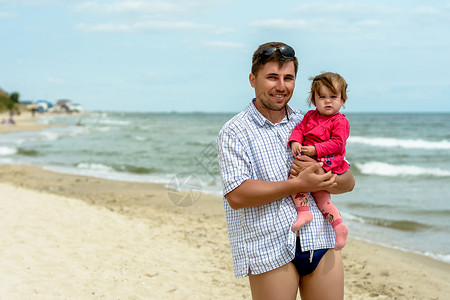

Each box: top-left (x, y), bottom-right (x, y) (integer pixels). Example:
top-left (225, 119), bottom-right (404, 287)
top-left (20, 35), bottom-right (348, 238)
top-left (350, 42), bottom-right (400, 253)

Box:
top-left (348, 136), bottom-right (450, 150)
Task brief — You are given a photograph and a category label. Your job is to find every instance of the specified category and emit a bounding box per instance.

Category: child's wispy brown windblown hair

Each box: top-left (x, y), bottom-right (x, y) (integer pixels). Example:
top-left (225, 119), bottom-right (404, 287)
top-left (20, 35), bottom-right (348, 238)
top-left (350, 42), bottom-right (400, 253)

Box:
top-left (308, 72), bottom-right (347, 106)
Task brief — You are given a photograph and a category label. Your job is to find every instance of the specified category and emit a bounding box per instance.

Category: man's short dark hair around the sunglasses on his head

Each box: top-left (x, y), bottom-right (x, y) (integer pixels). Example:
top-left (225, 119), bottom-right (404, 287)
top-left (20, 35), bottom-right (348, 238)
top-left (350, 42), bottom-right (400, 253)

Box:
top-left (252, 42), bottom-right (298, 76)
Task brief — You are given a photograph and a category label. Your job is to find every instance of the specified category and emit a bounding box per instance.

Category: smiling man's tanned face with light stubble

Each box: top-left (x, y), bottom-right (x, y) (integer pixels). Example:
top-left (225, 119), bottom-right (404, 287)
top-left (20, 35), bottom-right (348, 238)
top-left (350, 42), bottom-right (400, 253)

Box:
top-left (250, 61), bottom-right (295, 115)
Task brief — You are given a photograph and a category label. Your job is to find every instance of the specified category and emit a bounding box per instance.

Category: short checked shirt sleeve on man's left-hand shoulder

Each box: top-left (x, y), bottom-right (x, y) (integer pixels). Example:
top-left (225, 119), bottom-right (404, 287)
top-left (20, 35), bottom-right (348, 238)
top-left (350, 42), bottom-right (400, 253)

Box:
top-left (216, 127), bottom-right (252, 196)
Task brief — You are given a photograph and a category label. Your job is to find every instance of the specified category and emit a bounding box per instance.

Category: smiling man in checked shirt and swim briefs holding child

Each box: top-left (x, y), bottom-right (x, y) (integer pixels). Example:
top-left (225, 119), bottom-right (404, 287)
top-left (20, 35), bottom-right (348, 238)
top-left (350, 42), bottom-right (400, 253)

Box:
top-left (217, 43), bottom-right (354, 299)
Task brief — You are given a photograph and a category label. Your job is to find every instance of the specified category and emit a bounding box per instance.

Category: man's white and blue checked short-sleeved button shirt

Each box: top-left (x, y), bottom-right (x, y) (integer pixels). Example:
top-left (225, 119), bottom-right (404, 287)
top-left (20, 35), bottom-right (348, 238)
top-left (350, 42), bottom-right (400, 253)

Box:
top-left (217, 100), bottom-right (335, 278)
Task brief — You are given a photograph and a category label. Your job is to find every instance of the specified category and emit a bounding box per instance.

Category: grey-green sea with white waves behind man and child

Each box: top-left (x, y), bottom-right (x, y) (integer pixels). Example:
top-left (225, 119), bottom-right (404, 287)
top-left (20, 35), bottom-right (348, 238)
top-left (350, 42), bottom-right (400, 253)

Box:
top-left (0, 112), bottom-right (450, 263)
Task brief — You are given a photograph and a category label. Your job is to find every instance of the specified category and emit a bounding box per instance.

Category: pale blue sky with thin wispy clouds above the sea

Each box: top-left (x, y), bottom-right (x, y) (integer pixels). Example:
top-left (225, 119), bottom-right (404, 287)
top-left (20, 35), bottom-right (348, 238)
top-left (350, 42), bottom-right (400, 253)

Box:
top-left (0, 0), bottom-right (450, 113)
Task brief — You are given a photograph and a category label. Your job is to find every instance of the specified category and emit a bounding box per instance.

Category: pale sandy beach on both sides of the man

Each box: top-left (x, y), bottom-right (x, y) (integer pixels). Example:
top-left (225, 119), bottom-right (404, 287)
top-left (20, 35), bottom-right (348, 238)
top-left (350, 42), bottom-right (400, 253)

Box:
top-left (0, 120), bottom-right (450, 299)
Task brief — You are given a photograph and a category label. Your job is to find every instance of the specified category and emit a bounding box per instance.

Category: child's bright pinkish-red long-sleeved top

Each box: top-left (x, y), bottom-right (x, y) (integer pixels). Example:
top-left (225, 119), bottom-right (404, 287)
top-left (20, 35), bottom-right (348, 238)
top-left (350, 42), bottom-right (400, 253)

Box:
top-left (289, 109), bottom-right (350, 174)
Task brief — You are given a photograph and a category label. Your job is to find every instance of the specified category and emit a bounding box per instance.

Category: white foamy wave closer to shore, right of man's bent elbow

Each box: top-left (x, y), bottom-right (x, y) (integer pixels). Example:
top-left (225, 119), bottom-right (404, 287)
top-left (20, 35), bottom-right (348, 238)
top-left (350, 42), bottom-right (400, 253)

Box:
top-left (355, 161), bottom-right (450, 177)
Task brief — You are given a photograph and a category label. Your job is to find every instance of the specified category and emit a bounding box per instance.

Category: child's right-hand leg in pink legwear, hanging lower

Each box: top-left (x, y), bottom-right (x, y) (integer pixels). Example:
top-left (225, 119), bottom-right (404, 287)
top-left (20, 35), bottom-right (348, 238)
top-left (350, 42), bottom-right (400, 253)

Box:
top-left (312, 191), bottom-right (348, 250)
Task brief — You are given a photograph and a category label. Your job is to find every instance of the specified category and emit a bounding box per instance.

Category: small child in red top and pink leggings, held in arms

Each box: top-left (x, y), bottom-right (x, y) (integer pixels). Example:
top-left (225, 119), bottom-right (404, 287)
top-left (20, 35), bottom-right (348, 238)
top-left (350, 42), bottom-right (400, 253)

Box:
top-left (289, 72), bottom-right (350, 250)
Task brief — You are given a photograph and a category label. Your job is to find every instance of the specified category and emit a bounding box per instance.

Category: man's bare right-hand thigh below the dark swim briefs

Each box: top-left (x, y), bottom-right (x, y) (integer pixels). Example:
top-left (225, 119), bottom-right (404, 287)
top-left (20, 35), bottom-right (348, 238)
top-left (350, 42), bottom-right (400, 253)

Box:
top-left (300, 249), bottom-right (344, 300)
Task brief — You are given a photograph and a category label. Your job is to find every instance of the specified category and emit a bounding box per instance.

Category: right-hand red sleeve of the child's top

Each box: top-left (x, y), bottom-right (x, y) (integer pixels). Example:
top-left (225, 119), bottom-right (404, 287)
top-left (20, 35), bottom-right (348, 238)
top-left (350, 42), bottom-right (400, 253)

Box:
top-left (314, 117), bottom-right (350, 157)
